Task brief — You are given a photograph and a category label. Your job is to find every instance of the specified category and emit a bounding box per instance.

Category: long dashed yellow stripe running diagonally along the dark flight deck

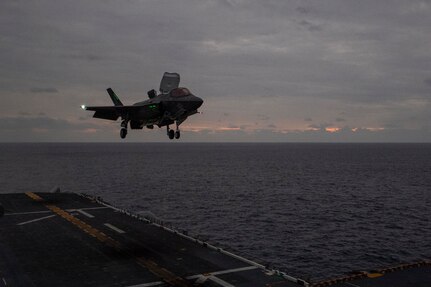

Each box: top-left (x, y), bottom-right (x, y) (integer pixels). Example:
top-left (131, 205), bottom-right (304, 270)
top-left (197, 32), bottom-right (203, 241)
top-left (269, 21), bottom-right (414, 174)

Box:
top-left (26, 192), bottom-right (192, 287)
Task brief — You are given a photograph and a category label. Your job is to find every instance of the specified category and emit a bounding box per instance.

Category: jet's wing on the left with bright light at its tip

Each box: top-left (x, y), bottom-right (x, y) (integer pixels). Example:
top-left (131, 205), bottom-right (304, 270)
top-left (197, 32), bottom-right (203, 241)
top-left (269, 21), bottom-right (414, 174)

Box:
top-left (82, 104), bottom-right (159, 121)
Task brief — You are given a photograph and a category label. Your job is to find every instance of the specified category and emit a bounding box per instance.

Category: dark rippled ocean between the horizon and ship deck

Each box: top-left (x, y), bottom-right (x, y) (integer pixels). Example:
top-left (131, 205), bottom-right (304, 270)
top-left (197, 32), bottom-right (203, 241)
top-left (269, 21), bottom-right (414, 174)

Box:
top-left (0, 142), bottom-right (431, 280)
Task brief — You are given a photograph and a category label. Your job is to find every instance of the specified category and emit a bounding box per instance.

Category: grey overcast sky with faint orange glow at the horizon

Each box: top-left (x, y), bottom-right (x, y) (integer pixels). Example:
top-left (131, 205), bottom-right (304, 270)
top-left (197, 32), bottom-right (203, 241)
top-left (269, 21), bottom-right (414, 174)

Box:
top-left (0, 0), bottom-right (431, 142)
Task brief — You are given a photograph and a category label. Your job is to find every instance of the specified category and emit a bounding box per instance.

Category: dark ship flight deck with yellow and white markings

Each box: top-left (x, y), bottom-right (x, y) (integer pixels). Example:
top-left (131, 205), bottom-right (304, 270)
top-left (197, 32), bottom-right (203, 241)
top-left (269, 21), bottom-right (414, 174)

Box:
top-left (0, 192), bottom-right (431, 287)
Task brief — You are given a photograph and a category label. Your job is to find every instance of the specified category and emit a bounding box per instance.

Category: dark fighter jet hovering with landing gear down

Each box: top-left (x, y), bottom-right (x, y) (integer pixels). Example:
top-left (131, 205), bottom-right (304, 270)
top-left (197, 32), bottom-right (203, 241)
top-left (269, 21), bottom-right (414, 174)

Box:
top-left (81, 72), bottom-right (203, 139)
